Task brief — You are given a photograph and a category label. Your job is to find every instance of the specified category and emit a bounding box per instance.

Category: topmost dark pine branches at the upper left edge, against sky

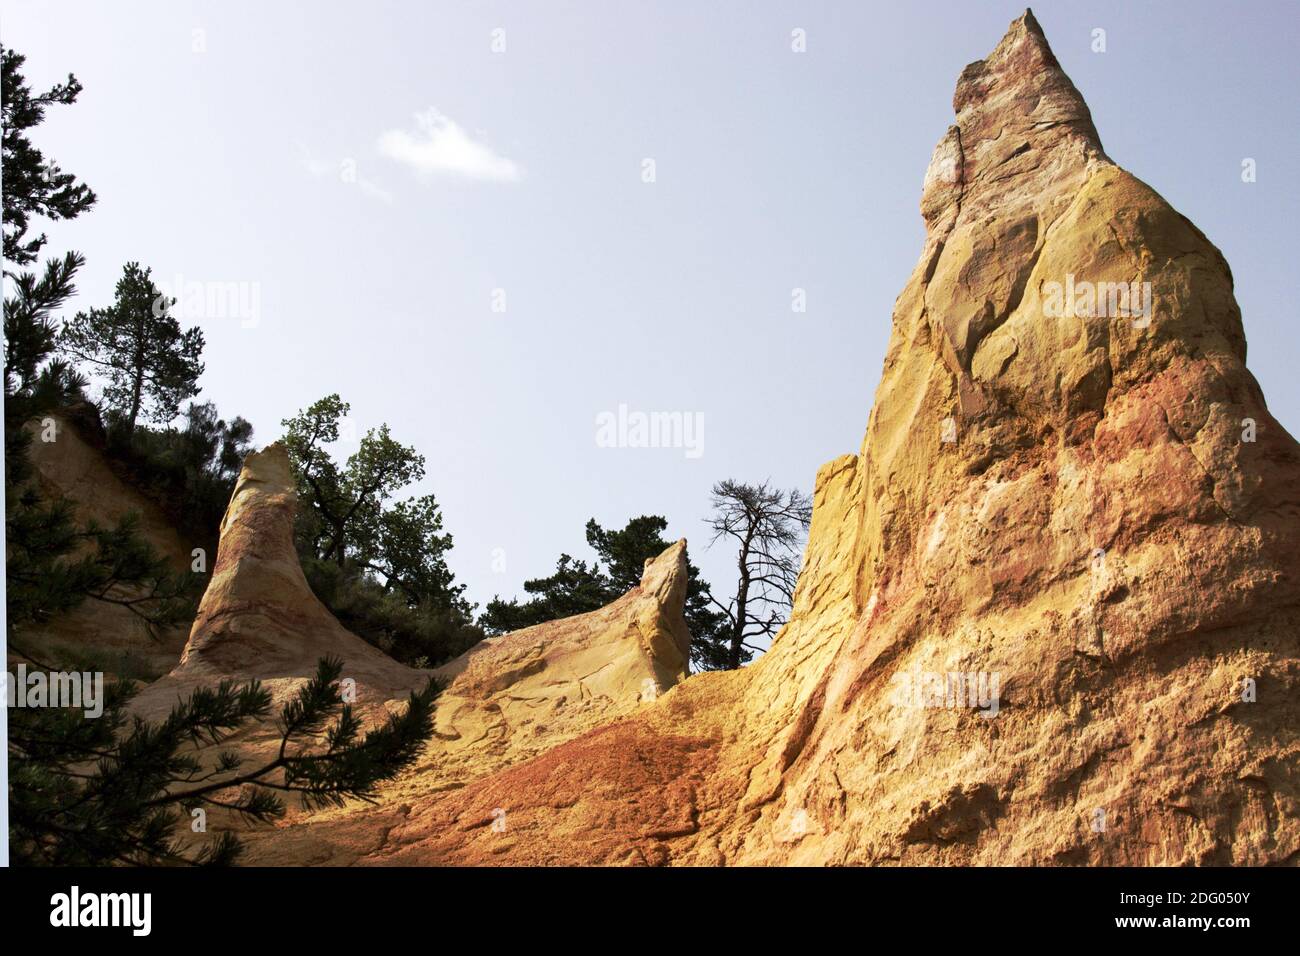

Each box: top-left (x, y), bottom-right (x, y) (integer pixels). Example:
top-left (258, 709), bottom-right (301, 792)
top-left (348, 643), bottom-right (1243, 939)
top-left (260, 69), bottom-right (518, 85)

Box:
top-left (0, 49), bottom-right (95, 274)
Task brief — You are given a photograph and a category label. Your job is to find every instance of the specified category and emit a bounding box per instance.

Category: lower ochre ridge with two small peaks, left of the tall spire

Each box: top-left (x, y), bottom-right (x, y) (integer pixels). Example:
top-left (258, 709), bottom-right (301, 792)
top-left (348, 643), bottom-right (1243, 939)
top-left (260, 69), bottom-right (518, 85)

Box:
top-left (133, 445), bottom-right (690, 862)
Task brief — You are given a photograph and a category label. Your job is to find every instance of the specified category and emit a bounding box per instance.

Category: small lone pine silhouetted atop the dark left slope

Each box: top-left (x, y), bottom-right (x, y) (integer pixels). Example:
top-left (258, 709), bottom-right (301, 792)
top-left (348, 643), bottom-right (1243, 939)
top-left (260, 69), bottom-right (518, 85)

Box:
top-left (59, 263), bottom-right (203, 436)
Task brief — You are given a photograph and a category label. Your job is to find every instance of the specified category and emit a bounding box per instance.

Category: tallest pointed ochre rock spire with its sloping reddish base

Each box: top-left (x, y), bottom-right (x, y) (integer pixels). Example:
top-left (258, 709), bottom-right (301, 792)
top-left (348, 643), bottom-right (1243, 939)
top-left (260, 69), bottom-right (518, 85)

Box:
top-left (261, 13), bottom-right (1300, 865)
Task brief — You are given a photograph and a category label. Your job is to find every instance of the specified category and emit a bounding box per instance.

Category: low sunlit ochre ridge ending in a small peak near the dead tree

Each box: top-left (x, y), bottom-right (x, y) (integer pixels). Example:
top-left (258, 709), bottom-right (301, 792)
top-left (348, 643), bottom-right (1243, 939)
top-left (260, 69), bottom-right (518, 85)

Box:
top-left (246, 541), bottom-right (690, 865)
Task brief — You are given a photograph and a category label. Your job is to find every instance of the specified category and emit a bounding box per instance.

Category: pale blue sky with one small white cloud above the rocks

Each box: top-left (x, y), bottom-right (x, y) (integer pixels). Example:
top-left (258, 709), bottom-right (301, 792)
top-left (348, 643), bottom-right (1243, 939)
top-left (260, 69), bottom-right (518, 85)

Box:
top-left (0, 0), bottom-right (1300, 634)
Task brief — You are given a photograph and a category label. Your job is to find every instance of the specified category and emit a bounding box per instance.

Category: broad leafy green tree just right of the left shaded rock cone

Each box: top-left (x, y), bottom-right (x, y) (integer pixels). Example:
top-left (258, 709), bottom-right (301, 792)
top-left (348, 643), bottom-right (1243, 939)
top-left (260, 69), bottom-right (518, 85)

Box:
top-left (281, 394), bottom-right (469, 614)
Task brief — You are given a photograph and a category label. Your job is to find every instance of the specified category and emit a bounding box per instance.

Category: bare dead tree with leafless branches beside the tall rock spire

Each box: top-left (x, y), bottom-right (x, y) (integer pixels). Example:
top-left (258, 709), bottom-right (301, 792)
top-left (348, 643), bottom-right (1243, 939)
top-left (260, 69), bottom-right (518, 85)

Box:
top-left (709, 480), bottom-right (813, 667)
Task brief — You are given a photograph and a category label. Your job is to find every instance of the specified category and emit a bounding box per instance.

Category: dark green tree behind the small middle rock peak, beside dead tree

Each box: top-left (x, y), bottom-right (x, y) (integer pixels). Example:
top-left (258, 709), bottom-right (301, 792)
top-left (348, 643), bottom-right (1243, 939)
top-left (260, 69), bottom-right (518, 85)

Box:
top-left (478, 515), bottom-right (748, 670)
